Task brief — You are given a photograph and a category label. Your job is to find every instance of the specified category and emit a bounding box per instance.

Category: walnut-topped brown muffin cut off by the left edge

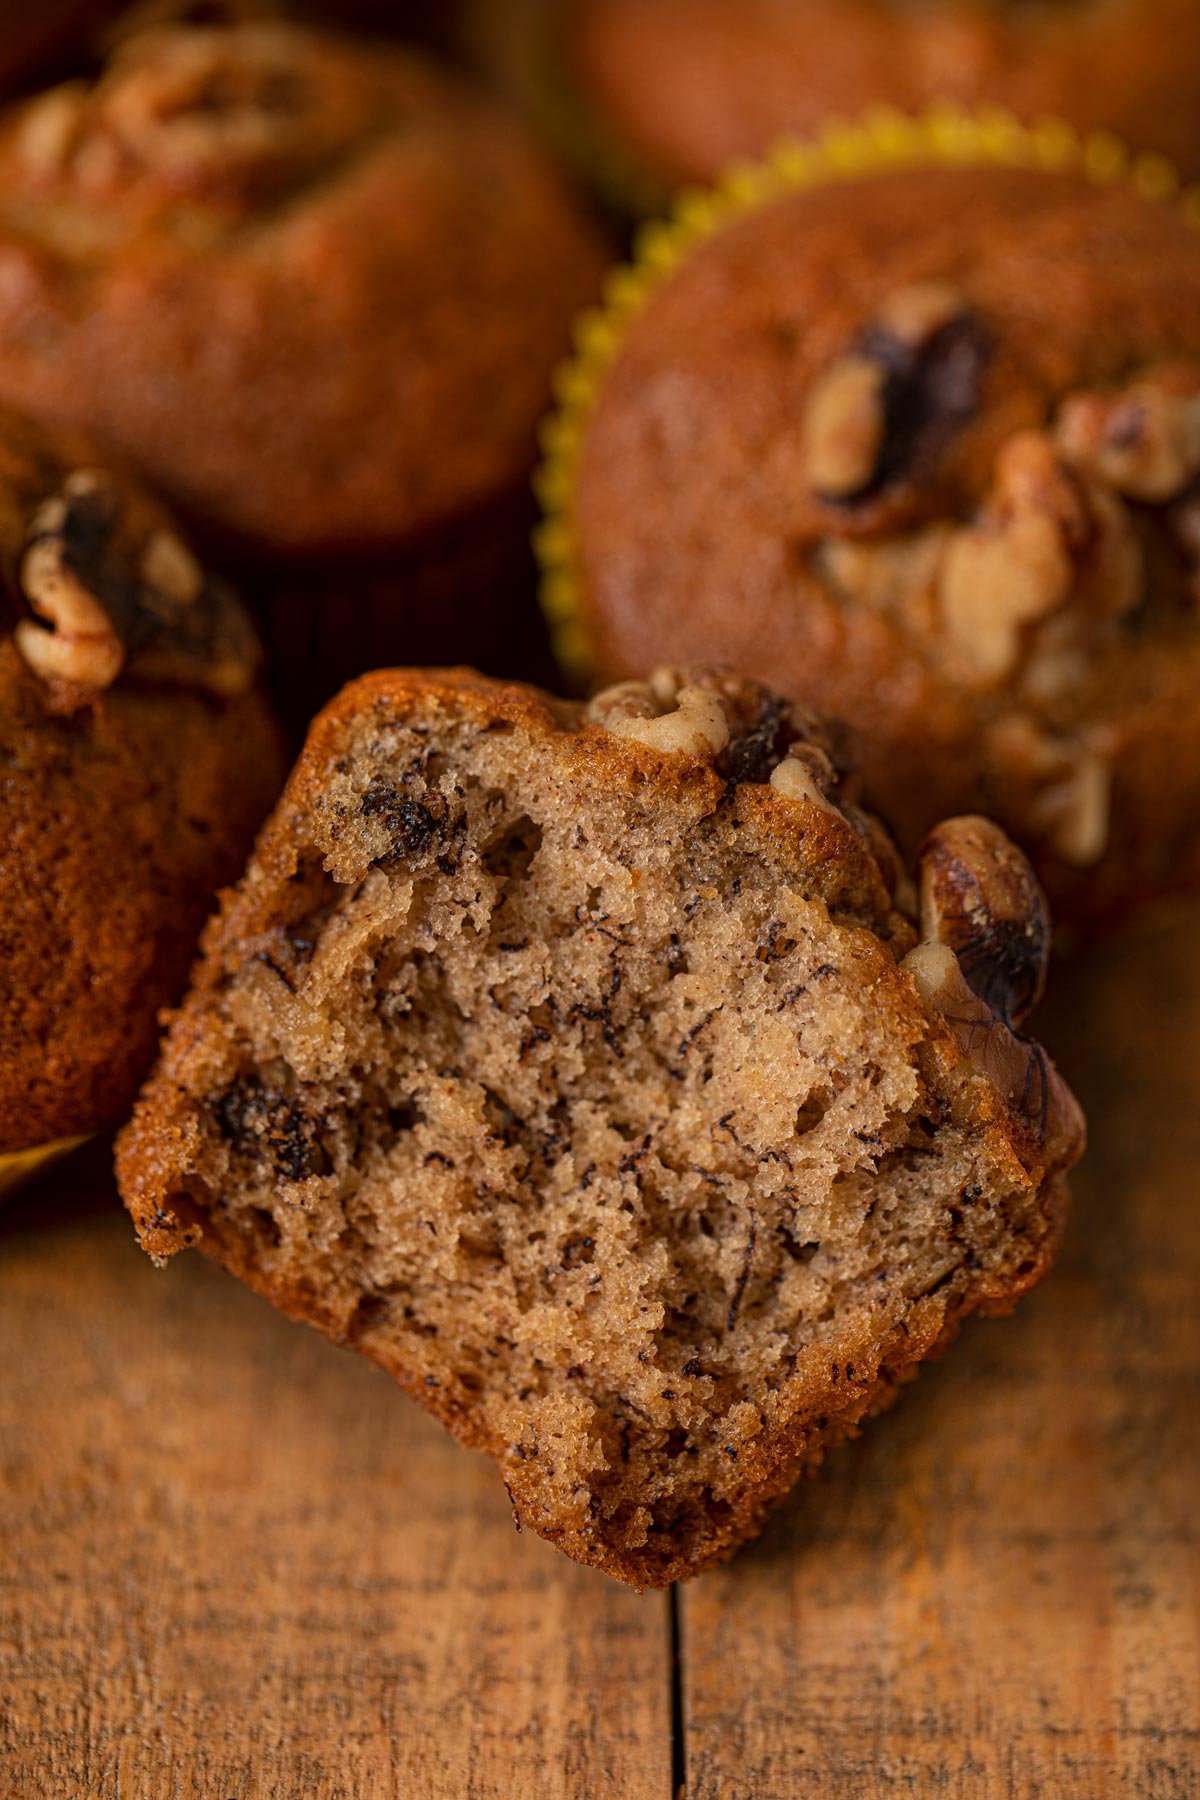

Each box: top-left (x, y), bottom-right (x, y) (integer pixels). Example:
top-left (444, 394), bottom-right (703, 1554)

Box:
top-left (0, 412), bottom-right (284, 1186)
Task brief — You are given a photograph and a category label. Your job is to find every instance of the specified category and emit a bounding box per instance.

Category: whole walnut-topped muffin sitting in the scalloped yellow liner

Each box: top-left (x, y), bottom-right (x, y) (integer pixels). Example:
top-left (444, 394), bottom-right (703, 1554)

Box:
top-left (547, 144), bottom-right (1200, 927)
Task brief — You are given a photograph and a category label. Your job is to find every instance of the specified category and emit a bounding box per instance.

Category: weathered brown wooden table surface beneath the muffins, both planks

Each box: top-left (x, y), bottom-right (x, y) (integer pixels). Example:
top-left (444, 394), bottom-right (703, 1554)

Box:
top-left (0, 918), bottom-right (1200, 1800)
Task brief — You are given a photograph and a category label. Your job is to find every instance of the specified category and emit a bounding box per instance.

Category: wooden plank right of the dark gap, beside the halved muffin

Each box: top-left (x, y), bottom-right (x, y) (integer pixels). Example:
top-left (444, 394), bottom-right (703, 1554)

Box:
top-left (682, 918), bottom-right (1200, 1800)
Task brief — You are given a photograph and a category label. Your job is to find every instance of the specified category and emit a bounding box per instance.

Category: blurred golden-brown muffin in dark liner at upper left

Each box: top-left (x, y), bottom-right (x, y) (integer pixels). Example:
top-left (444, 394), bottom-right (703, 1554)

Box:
top-left (0, 23), bottom-right (603, 716)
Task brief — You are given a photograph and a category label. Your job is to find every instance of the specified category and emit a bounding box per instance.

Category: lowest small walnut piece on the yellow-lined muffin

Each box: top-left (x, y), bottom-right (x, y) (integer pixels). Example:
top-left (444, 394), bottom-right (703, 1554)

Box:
top-left (988, 713), bottom-right (1112, 869)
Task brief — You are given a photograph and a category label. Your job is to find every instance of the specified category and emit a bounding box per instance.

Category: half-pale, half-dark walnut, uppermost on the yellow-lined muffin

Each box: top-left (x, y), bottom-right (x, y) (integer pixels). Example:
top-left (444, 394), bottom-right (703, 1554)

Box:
top-left (802, 284), bottom-right (988, 506)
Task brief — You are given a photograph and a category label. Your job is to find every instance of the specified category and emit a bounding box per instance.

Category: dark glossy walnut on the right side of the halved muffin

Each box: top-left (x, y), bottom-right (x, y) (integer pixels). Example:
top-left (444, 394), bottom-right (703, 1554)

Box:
top-left (901, 819), bottom-right (1083, 1161)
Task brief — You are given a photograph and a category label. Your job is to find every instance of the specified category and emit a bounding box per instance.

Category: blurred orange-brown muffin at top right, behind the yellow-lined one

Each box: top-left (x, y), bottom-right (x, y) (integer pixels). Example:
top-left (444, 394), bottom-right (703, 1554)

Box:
top-left (468, 0), bottom-right (1200, 211)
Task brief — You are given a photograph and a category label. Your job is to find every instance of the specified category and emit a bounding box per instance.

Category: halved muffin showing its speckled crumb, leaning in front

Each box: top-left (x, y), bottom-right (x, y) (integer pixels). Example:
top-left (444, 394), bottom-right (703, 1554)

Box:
top-left (119, 671), bottom-right (1081, 1586)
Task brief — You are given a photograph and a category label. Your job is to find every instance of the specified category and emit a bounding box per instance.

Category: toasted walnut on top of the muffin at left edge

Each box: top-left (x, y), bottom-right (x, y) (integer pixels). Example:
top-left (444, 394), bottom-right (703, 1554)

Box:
top-left (14, 470), bottom-right (257, 697)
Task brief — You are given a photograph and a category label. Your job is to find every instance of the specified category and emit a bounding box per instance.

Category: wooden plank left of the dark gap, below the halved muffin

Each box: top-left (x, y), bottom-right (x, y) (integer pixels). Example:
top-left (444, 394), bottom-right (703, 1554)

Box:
top-left (0, 1150), bottom-right (671, 1800)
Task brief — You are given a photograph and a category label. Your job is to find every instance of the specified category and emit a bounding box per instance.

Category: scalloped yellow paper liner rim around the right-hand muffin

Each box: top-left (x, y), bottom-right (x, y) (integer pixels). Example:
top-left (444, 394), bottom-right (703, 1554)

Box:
top-left (534, 104), bottom-right (1200, 684)
